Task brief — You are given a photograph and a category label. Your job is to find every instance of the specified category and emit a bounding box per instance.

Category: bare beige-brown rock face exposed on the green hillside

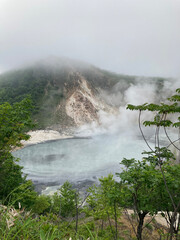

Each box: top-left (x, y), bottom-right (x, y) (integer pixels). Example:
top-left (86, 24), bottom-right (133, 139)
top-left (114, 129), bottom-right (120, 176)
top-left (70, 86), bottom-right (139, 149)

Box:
top-left (56, 72), bottom-right (116, 126)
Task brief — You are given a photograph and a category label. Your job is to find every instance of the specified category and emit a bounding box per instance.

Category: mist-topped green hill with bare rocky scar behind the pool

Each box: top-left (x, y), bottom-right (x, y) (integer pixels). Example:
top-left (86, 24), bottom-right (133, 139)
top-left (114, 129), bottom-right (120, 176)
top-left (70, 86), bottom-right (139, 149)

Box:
top-left (0, 57), bottom-right (167, 131)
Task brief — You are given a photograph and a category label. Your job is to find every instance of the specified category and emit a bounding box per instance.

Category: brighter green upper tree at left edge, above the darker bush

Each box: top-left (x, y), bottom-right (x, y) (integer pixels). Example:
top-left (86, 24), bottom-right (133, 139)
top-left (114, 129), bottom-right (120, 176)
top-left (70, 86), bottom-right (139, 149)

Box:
top-left (0, 98), bottom-right (33, 154)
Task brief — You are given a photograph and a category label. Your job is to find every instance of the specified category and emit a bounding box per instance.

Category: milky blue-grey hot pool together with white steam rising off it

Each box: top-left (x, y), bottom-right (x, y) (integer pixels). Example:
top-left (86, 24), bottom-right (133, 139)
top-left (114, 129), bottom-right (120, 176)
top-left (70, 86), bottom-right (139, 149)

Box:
top-left (14, 80), bottom-right (179, 193)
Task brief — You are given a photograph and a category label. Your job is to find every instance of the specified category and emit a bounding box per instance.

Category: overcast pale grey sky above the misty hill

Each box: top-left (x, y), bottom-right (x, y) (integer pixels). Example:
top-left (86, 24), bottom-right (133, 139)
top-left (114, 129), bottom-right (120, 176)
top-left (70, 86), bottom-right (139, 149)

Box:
top-left (0, 0), bottom-right (180, 77)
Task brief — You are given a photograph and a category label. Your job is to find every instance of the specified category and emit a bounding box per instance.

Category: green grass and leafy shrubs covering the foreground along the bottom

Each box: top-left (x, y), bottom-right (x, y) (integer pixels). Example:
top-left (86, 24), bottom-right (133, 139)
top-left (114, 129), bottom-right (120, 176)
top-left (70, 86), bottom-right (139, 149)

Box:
top-left (0, 172), bottom-right (177, 240)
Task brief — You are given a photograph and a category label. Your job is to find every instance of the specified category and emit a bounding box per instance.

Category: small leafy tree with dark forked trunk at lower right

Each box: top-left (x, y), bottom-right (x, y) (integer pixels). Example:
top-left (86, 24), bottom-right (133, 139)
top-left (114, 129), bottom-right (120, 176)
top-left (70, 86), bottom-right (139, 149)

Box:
top-left (118, 159), bottom-right (157, 240)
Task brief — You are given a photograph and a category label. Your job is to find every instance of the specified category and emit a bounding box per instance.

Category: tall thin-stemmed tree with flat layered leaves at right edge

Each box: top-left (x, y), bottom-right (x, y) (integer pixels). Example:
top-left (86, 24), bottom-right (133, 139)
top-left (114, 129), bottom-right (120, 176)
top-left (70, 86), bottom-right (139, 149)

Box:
top-left (127, 88), bottom-right (180, 240)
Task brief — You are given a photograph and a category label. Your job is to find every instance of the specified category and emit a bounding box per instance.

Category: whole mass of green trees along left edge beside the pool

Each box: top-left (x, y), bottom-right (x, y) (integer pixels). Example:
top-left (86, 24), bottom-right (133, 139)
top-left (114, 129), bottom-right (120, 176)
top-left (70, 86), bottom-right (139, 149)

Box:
top-left (0, 98), bottom-right (33, 204)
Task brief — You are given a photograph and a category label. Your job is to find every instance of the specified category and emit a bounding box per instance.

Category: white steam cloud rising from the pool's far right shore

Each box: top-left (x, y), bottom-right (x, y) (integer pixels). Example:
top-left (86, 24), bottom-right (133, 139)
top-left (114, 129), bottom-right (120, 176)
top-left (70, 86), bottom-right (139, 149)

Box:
top-left (77, 78), bottom-right (180, 138)
